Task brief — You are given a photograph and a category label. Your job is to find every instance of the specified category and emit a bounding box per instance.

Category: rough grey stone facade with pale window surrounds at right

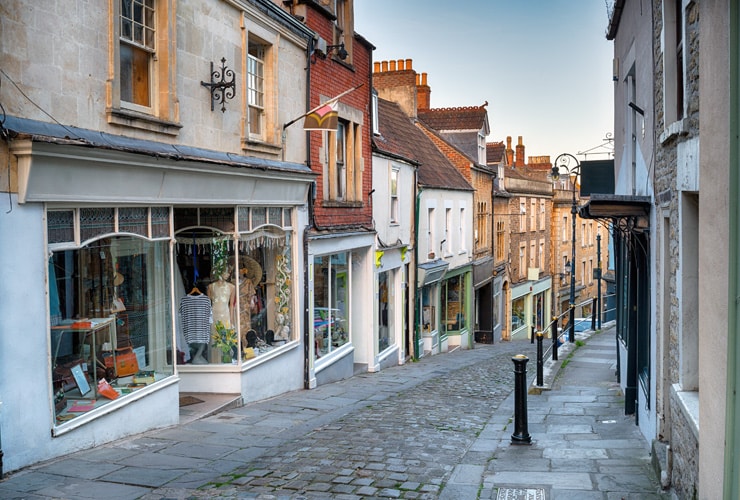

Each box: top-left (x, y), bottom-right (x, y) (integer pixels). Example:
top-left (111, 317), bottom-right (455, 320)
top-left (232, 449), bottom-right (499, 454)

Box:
top-left (653, 2), bottom-right (700, 498)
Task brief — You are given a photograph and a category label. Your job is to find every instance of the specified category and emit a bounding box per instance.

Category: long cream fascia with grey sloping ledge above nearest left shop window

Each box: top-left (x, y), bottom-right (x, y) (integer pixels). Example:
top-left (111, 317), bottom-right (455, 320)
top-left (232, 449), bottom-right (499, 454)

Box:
top-left (4, 116), bottom-right (315, 205)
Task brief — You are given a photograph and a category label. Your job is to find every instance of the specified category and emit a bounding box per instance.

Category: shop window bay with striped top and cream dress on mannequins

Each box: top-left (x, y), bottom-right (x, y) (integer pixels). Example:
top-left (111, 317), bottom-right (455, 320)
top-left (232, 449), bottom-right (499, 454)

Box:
top-left (174, 207), bottom-right (295, 365)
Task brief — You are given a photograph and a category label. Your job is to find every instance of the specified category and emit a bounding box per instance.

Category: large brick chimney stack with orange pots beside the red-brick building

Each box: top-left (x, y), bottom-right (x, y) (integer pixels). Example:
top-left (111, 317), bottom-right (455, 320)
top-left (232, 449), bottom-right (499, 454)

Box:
top-left (373, 59), bottom-right (420, 118)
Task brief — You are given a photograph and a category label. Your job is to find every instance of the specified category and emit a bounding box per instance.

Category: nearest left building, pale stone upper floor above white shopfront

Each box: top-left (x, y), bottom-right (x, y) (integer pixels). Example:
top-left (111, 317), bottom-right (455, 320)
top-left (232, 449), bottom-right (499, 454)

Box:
top-left (0, 0), bottom-right (315, 470)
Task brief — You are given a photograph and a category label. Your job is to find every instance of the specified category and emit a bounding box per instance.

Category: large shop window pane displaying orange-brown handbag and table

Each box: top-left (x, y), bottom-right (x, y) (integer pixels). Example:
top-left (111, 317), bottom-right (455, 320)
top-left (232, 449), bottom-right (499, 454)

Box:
top-left (49, 236), bottom-right (173, 424)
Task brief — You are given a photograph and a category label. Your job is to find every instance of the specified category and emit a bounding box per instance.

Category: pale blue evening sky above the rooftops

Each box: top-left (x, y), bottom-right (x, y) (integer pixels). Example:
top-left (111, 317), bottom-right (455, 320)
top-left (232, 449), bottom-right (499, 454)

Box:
top-left (355, 0), bottom-right (615, 161)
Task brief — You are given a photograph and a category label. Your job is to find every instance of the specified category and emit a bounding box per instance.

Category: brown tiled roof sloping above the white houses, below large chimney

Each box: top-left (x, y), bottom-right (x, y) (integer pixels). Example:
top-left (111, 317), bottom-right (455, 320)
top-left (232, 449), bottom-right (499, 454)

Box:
top-left (373, 99), bottom-right (473, 191)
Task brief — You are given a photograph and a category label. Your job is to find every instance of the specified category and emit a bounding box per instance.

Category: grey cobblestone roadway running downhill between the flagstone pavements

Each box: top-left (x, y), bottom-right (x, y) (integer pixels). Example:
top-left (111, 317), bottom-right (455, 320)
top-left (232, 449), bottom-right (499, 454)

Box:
top-left (197, 342), bottom-right (534, 499)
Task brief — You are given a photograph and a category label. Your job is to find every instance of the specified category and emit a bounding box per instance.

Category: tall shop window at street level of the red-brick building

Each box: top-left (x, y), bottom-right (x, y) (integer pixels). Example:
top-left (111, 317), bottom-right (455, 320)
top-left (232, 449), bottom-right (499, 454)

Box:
top-left (313, 252), bottom-right (350, 358)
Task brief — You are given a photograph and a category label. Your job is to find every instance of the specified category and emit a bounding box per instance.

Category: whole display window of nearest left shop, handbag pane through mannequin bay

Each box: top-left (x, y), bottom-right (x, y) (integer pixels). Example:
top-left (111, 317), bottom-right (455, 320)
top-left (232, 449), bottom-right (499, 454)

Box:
top-left (46, 207), bottom-right (296, 425)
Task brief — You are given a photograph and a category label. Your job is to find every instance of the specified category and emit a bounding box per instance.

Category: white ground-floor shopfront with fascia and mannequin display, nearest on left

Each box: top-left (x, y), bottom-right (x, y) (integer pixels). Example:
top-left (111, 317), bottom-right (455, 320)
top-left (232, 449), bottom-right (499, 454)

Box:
top-left (0, 119), bottom-right (313, 470)
